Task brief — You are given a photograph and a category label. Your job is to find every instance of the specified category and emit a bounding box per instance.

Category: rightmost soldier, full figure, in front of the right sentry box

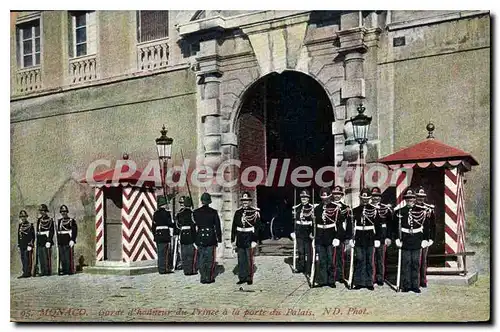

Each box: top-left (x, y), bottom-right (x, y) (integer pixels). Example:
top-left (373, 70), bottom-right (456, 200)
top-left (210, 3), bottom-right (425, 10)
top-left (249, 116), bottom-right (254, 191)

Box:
top-left (394, 189), bottom-right (429, 293)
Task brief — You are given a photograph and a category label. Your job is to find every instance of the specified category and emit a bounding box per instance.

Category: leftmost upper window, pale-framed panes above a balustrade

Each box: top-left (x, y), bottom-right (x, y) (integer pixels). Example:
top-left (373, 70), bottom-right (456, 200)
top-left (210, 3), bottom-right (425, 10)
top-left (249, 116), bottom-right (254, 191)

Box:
top-left (17, 20), bottom-right (41, 68)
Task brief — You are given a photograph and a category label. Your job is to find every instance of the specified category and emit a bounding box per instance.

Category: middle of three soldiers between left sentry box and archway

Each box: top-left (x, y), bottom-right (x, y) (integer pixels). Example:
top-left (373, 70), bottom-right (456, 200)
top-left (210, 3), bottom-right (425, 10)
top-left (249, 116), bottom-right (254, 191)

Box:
top-left (176, 197), bottom-right (198, 276)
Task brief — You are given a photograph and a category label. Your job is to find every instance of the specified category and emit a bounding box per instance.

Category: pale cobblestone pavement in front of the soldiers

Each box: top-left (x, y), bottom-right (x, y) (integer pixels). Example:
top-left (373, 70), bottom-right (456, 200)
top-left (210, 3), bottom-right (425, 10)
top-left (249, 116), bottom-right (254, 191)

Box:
top-left (11, 257), bottom-right (490, 322)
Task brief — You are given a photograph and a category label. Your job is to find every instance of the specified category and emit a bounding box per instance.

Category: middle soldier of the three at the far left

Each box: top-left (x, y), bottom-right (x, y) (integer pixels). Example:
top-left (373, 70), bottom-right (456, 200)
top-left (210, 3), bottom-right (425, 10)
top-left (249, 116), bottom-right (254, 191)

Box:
top-left (36, 204), bottom-right (54, 276)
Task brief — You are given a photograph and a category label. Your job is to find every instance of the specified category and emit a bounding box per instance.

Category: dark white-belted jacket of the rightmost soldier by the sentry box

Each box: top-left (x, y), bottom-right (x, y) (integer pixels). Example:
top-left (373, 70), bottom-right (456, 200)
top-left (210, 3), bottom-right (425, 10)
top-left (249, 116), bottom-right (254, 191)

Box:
top-left (393, 205), bottom-right (429, 250)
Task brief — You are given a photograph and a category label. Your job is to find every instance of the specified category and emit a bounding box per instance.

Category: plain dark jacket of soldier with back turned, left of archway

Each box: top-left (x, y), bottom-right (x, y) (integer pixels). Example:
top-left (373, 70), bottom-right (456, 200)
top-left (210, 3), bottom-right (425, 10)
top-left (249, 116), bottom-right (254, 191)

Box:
top-left (193, 205), bottom-right (222, 247)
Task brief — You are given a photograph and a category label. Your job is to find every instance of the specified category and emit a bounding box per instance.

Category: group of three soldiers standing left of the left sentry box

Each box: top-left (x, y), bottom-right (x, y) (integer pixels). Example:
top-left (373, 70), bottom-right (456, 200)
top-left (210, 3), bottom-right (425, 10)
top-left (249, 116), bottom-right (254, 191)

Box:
top-left (17, 204), bottom-right (78, 278)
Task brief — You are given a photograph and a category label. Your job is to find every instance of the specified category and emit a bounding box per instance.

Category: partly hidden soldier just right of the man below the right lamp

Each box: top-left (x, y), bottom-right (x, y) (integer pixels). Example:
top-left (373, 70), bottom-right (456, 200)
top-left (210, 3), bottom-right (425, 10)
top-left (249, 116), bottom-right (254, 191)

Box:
top-left (371, 187), bottom-right (392, 286)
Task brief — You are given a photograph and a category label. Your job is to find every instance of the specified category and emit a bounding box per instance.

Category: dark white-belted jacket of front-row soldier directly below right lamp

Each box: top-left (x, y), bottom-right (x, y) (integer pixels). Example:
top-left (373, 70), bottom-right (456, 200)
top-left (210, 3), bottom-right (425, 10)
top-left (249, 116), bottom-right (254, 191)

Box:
top-left (346, 204), bottom-right (382, 247)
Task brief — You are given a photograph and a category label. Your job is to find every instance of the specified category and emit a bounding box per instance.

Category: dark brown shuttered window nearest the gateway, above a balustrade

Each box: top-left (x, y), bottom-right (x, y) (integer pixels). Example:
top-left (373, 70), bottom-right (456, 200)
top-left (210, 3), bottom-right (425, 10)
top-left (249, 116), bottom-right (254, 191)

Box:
top-left (137, 10), bottom-right (168, 43)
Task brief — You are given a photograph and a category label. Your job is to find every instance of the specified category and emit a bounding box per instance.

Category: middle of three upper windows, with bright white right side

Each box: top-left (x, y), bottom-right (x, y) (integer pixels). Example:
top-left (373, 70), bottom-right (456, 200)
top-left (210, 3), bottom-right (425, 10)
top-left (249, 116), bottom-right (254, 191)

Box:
top-left (70, 11), bottom-right (96, 57)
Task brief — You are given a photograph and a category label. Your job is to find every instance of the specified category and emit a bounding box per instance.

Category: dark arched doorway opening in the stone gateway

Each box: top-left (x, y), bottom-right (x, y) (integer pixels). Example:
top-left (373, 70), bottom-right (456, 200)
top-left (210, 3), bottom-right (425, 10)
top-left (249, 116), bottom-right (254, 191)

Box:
top-left (235, 71), bottom-right (335, 249)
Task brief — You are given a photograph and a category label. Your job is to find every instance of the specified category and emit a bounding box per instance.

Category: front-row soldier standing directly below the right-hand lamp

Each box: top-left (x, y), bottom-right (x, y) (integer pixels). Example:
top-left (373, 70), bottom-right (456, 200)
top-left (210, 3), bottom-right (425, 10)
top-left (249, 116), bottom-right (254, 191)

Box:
top-left (346, 188), bottom-right (381, 290)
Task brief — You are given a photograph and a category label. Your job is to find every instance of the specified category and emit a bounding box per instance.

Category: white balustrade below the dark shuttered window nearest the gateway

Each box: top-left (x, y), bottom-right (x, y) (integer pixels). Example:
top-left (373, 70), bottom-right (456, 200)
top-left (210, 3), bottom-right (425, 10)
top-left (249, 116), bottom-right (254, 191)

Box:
top-left (137, 38), bottom-right (169, 71)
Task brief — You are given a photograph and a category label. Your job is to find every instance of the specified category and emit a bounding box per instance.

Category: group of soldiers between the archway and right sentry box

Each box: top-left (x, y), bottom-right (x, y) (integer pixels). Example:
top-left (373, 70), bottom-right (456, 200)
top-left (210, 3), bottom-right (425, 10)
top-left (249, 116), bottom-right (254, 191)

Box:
top-left (292, 186), bottom-right (435, 293)
